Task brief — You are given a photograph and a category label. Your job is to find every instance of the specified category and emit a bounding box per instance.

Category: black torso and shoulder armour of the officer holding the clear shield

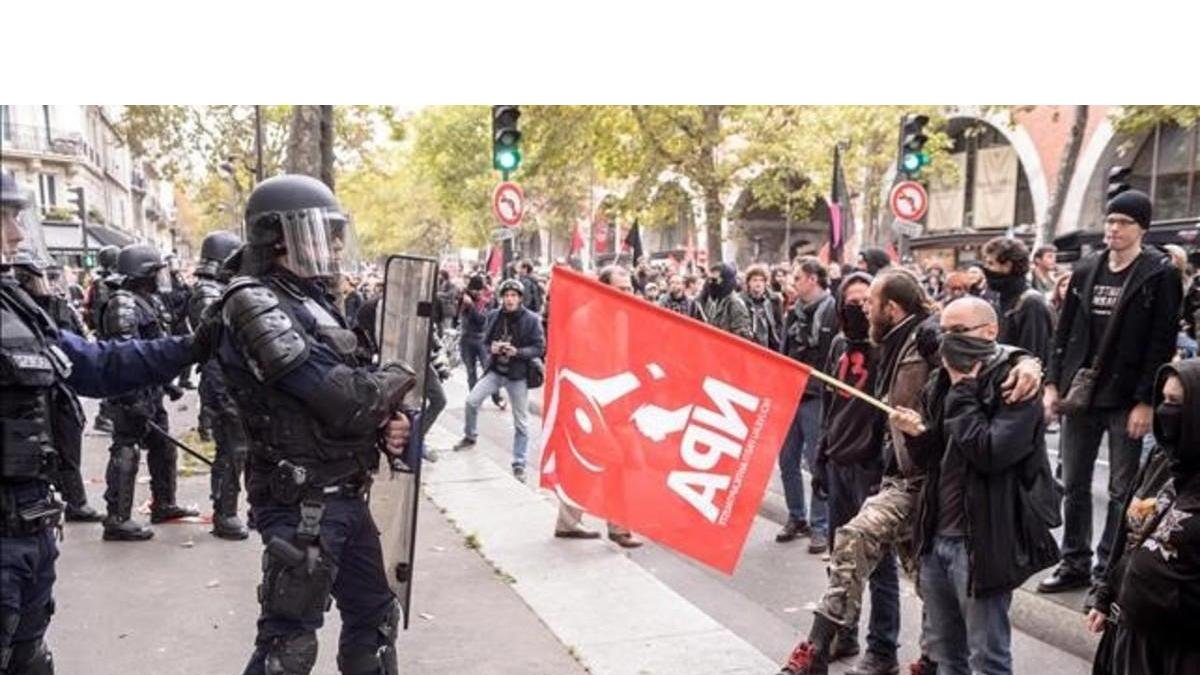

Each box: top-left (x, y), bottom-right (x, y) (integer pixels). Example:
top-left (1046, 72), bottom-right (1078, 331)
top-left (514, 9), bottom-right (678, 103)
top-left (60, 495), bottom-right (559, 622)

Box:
top-left (220, 276), bottom-right (379, 503)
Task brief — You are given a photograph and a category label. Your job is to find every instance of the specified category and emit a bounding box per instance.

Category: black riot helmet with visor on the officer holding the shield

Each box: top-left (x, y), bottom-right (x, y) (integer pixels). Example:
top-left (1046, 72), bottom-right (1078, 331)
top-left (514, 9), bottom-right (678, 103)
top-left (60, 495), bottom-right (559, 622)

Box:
top-left (246, 174), bottom-right (358, 277)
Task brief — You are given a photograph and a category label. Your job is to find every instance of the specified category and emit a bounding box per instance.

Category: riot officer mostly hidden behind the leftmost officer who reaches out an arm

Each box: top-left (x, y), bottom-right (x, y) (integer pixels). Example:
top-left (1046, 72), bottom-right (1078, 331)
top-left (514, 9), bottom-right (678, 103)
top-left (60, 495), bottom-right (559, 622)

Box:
top-left (12, 251), bottom-right (103, 522)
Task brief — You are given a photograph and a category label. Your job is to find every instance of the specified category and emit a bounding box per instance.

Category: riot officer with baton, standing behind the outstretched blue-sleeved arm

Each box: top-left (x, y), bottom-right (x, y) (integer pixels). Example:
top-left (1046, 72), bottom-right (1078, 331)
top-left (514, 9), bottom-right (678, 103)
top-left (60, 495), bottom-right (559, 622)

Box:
top-left (100, 239), bottom-right (199, 542)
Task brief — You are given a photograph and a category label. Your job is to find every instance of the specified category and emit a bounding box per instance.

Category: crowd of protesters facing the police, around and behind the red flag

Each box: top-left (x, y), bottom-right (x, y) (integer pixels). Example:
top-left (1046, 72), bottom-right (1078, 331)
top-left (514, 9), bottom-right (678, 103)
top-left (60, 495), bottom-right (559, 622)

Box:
top-left (444, 190), bottom-right (1200, 675)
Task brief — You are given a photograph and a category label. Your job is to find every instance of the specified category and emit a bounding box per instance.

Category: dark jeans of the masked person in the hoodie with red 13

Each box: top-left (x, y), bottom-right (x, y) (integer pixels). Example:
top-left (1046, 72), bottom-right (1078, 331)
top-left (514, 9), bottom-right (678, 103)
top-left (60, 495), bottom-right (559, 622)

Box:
top-left (826, 460), bottom-right (900, 658)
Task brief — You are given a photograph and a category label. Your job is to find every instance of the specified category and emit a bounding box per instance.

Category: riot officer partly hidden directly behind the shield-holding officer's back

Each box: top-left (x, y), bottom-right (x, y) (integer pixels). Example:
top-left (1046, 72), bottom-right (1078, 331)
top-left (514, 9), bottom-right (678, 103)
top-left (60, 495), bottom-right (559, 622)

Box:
top-left (187, 231), bottom-right (250, 539)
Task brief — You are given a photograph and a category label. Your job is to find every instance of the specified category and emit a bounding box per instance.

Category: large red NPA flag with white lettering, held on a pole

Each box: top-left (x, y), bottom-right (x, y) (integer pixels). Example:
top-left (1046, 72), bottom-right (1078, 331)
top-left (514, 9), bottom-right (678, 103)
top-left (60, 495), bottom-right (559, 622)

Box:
top-left (541, 267), bottom-right (809, 573)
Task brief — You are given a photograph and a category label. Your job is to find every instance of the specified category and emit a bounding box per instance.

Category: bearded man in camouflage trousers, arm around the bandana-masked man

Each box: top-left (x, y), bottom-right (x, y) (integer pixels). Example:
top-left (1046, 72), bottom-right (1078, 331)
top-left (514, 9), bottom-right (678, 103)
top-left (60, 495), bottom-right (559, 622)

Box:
top-left (780, 269), bottom-right (1042, 675)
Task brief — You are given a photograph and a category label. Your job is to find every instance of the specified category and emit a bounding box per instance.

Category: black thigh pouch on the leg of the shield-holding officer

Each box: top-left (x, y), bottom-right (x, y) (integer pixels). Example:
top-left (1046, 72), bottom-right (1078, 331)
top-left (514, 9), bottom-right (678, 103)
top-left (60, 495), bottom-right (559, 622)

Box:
top-left (258, 537), bottom-right (337, 621)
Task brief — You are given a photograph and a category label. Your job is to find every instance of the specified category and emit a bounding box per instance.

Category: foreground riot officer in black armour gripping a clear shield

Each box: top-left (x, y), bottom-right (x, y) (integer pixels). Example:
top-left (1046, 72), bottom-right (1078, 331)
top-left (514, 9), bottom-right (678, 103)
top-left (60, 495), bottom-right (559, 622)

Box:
top-left (216, 175), bottom-right (416, 675)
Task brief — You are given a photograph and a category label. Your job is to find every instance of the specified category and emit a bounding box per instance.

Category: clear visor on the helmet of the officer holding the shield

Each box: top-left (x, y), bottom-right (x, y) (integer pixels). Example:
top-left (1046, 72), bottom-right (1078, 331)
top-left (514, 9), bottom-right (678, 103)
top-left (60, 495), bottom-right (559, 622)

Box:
top-left (280, 209), bottom-right (359, 277)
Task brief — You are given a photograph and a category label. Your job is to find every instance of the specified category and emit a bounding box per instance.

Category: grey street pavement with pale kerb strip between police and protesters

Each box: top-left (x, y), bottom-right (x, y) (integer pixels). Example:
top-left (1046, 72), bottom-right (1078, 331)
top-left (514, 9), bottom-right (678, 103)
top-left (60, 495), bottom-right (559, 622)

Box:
top-left (49, 371), bottom-right (1104, 675)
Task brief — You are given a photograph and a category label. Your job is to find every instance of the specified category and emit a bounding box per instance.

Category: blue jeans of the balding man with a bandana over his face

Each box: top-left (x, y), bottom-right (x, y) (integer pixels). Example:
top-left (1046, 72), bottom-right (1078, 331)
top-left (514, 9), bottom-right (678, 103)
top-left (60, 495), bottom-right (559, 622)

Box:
top-left (920, 536), bottom-right (1013, 675)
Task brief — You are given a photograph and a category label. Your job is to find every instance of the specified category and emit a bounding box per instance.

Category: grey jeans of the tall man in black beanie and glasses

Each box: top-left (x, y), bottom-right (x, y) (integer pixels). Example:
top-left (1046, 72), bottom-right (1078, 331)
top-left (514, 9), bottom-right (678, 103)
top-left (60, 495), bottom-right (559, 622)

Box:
top-left (1061, 406), bottom-right (1142, 578)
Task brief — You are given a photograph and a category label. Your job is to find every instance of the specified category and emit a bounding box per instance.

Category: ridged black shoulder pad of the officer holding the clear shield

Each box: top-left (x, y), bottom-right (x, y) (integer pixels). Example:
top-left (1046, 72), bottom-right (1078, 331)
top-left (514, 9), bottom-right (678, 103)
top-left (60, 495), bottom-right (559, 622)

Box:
top-left (221, 277), bottom-right (308, 382)
